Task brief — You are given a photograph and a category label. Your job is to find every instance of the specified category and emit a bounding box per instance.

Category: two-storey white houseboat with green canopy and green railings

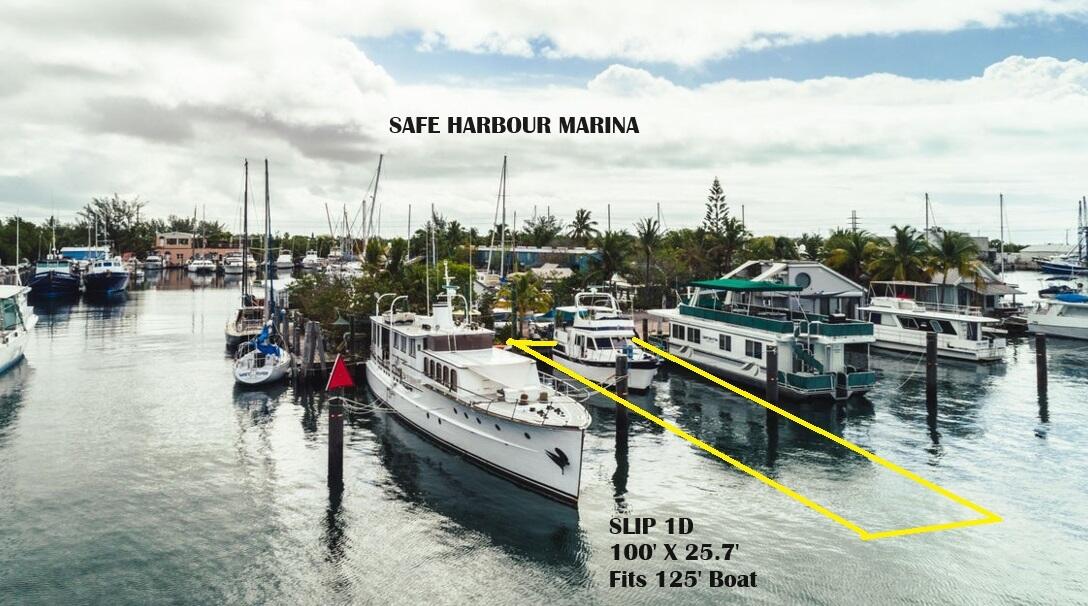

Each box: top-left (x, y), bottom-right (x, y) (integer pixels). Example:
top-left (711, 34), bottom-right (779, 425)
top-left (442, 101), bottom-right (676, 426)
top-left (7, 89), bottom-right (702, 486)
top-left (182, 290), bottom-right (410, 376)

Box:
top-left (650, 279), bottom-right (876, 400)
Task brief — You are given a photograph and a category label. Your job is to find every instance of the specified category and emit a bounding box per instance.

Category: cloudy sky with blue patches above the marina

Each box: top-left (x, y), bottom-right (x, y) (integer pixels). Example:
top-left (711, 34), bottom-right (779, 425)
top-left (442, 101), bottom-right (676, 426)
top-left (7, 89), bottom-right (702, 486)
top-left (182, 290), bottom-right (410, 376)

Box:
top-left (0, 0), bottom-right (1088, 243)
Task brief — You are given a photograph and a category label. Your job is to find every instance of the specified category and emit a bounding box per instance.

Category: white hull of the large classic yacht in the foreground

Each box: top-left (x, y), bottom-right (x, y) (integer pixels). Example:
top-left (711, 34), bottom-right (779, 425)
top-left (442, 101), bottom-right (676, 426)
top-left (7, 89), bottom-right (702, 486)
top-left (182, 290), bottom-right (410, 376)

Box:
top-left (367, 360), bottom-right (584, 503)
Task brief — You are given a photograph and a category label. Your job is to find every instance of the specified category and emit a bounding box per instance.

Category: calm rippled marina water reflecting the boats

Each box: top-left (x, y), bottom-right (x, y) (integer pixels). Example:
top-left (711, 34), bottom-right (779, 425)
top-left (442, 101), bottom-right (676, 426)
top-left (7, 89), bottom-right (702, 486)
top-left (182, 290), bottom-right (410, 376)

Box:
top-left (0, 273), bottom-right (1088, 604)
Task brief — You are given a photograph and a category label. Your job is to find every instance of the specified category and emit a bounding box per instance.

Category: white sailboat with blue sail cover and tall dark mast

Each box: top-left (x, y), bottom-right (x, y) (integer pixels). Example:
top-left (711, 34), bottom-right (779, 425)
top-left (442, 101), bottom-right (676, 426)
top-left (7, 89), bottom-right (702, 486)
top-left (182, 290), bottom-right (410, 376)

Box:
top-left (234, 160), bottom-right (292, 385)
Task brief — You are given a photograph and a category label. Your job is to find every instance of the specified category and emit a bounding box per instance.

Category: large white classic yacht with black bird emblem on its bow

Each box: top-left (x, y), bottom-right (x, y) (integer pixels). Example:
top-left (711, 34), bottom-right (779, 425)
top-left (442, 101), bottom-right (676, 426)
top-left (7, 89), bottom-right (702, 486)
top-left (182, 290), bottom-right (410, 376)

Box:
top-left (367, 266), bottom-right (590, 503)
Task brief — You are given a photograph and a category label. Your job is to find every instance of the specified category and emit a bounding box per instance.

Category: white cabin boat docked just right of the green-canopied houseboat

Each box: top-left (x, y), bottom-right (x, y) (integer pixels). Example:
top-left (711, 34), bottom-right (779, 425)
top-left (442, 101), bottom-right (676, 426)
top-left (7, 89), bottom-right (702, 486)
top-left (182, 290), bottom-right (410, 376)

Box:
top-left (858, 282), bottom-right (1005, 362)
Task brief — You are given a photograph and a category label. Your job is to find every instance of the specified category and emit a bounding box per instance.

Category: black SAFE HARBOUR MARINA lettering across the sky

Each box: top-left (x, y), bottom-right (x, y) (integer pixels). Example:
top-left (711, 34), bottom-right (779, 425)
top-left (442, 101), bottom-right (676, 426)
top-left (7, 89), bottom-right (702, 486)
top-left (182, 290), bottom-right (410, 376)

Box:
top-left (390, 115), bottom-right (639, 135)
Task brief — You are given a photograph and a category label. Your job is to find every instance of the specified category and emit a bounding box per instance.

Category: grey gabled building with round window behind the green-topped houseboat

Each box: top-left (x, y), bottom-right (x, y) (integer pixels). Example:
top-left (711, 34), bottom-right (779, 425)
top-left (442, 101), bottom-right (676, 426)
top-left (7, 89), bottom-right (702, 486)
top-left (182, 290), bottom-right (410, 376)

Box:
top-left (724, 260), bottom-right (865, 318)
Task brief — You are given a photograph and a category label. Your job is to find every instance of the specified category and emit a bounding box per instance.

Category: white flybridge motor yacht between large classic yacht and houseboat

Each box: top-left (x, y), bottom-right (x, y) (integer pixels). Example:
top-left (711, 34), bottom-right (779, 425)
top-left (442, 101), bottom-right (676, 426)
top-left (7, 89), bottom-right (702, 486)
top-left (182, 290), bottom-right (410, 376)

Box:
top-left (552, 289), bottom-right (660, 392)
